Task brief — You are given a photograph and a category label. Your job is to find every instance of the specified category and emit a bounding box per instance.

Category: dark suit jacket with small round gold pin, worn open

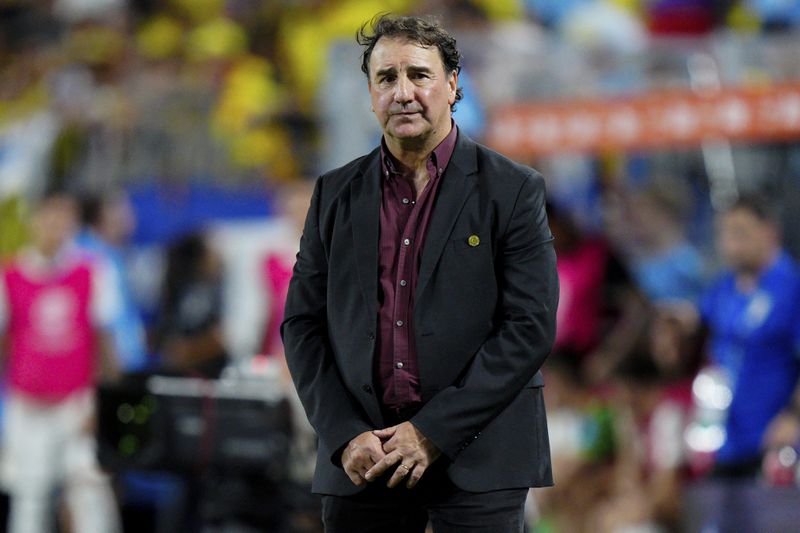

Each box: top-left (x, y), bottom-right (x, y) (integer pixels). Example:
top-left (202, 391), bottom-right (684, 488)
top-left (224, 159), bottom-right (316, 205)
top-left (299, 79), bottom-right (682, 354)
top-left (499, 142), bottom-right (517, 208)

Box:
top-left (281, 133), bottom-right (558, 495)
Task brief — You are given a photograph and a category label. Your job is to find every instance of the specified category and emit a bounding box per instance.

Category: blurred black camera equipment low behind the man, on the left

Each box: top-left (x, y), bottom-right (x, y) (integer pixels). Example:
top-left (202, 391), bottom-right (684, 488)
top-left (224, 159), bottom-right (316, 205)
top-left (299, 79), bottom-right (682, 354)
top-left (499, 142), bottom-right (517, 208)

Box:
top-left (98, 374), bottom-right (291, 480)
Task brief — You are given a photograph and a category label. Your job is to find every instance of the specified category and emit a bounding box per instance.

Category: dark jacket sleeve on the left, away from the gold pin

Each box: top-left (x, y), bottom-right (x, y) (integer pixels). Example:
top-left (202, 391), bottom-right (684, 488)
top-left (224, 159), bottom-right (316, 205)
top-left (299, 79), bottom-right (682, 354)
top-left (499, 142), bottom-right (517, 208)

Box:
top-left (281, 178), bottom-right (375, 466)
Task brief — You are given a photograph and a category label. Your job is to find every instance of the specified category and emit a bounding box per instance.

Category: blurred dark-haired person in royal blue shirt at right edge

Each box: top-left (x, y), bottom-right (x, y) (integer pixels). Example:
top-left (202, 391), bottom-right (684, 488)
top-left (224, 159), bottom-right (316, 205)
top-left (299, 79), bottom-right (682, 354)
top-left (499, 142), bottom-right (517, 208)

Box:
top-left (700, 196), bottom-right (800, 477)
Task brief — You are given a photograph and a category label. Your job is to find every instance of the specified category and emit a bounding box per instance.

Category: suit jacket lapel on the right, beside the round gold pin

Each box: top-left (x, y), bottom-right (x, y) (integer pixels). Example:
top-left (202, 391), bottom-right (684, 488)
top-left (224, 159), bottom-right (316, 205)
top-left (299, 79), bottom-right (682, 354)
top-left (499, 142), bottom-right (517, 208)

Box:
top-left (416, 132), bottom-right (477, 301)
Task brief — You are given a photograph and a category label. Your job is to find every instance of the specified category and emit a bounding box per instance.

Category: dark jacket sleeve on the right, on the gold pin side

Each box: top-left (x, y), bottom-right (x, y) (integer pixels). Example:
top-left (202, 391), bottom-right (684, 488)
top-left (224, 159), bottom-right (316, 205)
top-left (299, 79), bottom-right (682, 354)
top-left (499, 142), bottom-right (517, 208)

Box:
top-left (411, 173), bottom-right (558, 460)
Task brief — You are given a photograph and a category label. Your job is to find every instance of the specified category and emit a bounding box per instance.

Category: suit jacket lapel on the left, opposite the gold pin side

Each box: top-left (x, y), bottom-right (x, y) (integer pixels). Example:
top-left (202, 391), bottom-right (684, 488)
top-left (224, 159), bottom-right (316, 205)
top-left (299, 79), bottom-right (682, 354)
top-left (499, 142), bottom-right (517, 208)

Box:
top-left (350, 149), bottom-right (381, 317)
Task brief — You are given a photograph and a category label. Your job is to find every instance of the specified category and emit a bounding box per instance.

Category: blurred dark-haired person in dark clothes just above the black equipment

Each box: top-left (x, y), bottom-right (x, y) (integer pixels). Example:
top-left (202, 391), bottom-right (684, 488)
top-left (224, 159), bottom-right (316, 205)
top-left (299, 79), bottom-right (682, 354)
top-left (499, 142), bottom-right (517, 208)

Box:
top-left (159, 233), bottom-right (228, 378)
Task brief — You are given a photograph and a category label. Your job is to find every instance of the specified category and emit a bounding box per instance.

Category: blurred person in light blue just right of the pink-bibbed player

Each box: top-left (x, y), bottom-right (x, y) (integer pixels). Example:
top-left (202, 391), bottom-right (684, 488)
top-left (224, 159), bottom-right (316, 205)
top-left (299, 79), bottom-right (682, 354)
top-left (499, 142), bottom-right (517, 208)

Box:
top-left (77, 192), bottom-right (148, 372)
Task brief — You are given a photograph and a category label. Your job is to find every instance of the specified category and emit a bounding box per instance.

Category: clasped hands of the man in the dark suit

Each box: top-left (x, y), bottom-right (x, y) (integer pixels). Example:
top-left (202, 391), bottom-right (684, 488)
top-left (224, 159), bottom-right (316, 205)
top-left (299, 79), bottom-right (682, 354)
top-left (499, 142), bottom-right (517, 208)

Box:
top-left (342, 422), bottom-right (441, 488)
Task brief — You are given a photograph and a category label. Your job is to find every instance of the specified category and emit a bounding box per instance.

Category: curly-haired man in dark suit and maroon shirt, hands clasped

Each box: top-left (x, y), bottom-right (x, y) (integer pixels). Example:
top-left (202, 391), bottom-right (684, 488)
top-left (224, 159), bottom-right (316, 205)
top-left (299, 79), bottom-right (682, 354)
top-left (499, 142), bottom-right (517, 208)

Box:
top-left (282, 16), bottom-right (558, 533)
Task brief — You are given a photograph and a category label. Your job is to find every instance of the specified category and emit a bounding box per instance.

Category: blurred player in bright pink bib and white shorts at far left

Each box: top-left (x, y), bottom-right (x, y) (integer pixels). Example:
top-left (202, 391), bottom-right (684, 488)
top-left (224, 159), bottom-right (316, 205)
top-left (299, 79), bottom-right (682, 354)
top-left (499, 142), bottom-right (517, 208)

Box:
top-left (0, 190), bottom-right (119, 533)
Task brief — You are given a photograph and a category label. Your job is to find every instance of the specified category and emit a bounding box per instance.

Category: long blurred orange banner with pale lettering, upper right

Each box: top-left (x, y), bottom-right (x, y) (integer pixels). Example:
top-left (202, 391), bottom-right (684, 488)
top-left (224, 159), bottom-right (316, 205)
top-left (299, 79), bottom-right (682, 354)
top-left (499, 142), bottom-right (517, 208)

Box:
top-left (487, 82), bottom-right (800, 158)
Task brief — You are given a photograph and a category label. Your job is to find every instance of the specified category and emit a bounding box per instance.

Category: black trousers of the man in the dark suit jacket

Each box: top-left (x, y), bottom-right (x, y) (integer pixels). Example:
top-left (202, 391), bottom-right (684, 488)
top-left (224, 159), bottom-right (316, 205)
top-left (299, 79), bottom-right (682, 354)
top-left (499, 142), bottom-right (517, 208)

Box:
top-left (322, 461), bottom-right (528, 533)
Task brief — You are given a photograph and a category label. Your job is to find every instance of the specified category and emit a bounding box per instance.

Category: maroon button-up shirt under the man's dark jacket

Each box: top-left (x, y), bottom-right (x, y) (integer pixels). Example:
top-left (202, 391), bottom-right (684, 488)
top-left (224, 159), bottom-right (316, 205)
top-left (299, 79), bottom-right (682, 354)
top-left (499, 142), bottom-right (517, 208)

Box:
top-left (377, 123), bottom-right (457, 409)
